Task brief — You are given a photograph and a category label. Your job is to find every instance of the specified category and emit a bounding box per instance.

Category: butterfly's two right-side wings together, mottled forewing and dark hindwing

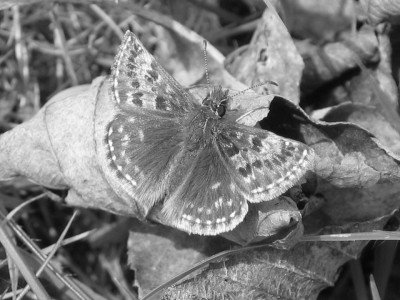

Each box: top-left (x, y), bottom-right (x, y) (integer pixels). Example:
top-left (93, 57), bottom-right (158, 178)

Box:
top-left (164, 121), bottom-right (313, 234)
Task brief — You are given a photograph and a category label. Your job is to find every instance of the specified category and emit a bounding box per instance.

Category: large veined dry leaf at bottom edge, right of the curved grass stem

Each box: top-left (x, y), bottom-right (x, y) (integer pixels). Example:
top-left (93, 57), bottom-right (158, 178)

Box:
top-left (166, 215), bottom-right (391, 299)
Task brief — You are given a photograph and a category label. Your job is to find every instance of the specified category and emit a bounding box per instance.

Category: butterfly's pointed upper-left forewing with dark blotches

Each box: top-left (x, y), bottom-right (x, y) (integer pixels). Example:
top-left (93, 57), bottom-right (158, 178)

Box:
top-left (110, 31), bottom-right (197, 115)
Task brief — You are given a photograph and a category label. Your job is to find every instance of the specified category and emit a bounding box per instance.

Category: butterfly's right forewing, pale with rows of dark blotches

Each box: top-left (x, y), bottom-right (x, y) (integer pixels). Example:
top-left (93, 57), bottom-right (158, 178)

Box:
top-left (218, 124), bottom-right (313, 202)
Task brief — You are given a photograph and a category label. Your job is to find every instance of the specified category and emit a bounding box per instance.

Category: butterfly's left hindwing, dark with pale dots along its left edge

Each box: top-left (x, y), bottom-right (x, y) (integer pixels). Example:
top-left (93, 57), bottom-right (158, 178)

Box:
top-left (106, 113), bottom-right (184, 205)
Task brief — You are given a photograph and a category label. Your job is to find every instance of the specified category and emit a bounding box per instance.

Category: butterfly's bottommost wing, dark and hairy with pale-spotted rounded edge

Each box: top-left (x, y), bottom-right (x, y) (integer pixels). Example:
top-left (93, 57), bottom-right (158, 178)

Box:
top-left (164, 144), bottom-right (248, 235)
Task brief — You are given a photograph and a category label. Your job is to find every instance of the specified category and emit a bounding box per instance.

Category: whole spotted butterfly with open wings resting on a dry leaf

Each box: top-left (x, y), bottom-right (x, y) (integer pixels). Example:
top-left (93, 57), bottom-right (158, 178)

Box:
top-left (104, 31), bottom-right (313, 235)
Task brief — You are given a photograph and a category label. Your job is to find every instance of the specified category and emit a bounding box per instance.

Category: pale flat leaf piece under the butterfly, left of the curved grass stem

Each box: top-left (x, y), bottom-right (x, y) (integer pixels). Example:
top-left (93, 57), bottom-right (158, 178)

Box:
top-left (128, 222), bottom-right (212, 295)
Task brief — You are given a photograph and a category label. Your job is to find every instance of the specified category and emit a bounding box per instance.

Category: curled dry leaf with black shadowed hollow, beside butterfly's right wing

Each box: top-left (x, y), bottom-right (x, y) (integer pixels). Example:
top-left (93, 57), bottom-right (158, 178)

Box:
top-left (261, 97), bottom-right (400, 187)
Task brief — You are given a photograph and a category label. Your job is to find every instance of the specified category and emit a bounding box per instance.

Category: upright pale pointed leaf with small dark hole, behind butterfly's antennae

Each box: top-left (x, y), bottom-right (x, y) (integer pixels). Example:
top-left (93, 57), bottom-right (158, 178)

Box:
top-left (225, 3), bottom-right (304, 103)
